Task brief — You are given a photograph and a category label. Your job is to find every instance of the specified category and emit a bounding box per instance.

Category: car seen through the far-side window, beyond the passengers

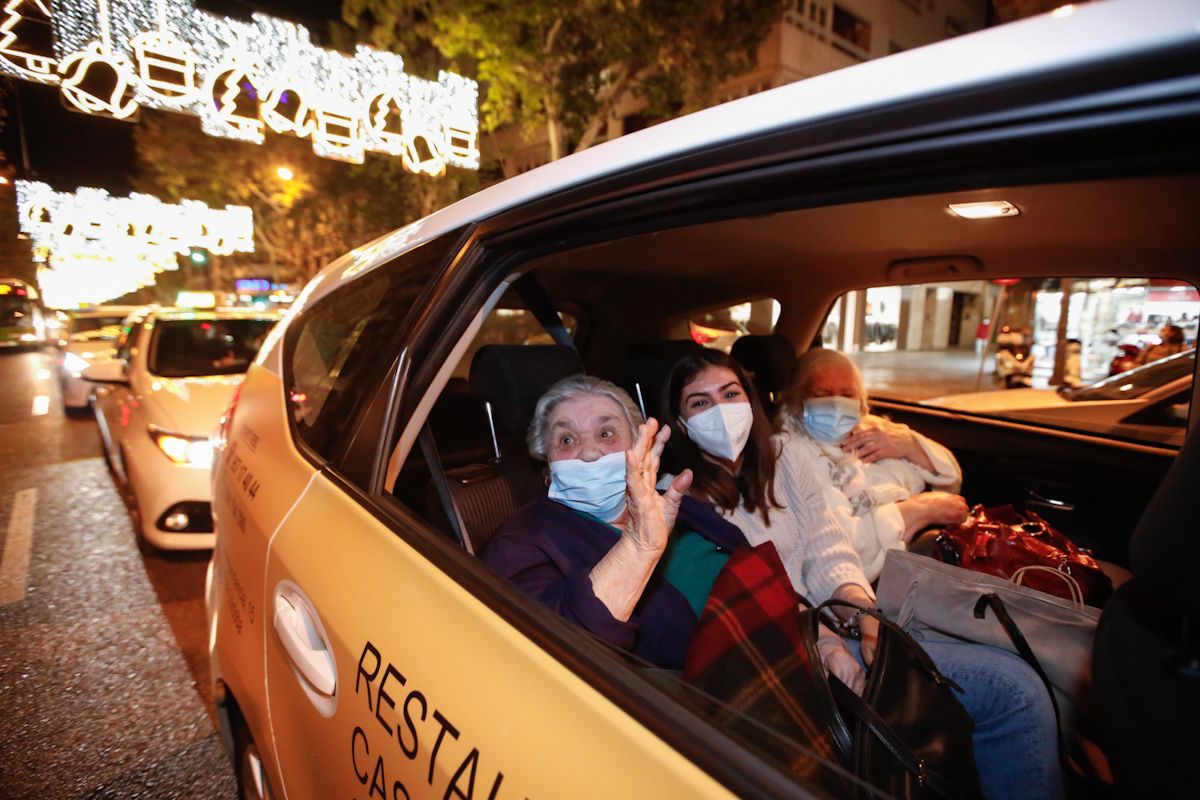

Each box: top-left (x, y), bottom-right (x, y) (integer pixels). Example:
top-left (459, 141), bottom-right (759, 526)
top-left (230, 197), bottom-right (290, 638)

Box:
top-left (922, 348), bottom-right (1196, 444)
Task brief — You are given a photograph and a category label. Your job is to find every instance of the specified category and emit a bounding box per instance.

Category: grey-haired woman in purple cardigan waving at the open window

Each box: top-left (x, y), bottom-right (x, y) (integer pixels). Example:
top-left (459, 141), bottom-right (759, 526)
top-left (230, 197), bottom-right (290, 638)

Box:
top-left (482, 375), bottom-right (746, 669)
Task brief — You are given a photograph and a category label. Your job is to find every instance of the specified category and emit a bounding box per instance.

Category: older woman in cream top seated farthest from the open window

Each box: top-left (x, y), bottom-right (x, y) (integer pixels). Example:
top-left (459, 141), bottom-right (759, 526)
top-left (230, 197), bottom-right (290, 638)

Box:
top-left (780, 348), bottom-right (967, 581)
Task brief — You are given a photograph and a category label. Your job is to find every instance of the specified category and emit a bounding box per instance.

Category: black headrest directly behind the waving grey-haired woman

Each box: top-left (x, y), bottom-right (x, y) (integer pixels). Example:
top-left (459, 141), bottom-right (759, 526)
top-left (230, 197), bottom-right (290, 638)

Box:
top-left (470, 344), bottom-right (583, 435)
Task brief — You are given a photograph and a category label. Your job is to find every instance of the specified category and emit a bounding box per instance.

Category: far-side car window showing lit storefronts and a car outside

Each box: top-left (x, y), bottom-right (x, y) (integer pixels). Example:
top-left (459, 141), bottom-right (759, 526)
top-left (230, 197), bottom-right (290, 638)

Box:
top-left (821, 278), bottom-right (1200, 446)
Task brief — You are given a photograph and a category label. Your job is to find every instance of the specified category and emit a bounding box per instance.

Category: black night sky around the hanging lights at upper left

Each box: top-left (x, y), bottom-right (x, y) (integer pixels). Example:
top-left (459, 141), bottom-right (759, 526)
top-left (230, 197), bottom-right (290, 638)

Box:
top-left (0, 0), bottom-right (341, 194)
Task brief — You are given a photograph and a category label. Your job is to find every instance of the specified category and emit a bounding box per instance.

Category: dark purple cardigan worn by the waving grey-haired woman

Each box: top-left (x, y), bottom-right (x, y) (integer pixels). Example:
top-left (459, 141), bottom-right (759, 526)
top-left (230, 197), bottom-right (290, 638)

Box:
top-left (481, 497), bottom-right (748, 669)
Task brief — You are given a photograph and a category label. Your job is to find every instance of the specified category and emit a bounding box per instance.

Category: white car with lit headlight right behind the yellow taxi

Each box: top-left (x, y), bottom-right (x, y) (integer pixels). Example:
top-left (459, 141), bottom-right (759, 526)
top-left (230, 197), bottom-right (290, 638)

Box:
top-left (83, 308), bottom-right (278, 549)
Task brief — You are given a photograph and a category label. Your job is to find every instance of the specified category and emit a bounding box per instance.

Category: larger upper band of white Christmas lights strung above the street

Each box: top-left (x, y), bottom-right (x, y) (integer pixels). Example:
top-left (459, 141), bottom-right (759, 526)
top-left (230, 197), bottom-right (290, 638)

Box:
top-left (0, 0), bottom-right (479, 176)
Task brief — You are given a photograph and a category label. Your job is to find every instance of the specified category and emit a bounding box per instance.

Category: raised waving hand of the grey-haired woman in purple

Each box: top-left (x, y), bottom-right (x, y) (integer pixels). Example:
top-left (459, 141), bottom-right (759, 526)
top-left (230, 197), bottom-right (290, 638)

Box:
top-left (625, 417), bottom-right (691, 553)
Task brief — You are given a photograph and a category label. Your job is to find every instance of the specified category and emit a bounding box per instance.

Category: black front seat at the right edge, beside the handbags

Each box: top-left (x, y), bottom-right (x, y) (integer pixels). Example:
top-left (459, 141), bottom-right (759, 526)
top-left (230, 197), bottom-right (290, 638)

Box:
top-left (1092, 419), bottom-right (1200, 798)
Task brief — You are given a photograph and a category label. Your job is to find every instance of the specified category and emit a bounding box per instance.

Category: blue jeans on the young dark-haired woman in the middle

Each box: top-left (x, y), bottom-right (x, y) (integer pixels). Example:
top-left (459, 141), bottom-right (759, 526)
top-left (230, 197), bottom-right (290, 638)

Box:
top-left (846, 639), bottom-right (1062, 800)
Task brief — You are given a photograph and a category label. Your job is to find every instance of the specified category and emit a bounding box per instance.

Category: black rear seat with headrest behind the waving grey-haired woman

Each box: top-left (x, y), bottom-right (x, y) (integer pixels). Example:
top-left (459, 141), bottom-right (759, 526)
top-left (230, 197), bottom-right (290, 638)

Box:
top-left (428, 344), bottom-right (583, 554)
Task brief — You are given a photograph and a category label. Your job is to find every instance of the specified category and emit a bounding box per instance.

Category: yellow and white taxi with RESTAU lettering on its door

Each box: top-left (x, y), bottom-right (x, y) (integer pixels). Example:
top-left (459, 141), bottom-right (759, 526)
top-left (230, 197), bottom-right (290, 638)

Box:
top-left (206, 1), bottom-right (1200, 799)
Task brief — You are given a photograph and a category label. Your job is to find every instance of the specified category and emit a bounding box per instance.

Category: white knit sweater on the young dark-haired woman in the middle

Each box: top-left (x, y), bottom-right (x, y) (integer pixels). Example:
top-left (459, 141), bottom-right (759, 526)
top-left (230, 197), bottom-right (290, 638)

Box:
top-left (725, 433), bottom-right (875, 603)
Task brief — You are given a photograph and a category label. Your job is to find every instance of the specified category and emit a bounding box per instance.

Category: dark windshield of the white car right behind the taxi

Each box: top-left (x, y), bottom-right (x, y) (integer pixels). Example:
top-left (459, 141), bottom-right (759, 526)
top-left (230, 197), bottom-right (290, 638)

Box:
top-left (150, 319), bottom-right (275, 378)
